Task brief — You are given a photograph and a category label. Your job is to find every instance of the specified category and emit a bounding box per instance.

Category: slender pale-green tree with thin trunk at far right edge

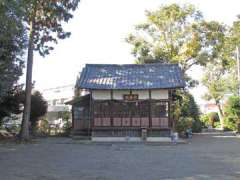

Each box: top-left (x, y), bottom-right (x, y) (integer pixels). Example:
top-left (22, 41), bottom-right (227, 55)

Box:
top-left (202, 15), bottom-right (240, 129)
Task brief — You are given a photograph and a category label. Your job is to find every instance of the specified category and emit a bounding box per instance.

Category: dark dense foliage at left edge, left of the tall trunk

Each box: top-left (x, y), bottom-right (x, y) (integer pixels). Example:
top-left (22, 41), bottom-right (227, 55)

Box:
top-left (0, 0), bottom-right (27, 102)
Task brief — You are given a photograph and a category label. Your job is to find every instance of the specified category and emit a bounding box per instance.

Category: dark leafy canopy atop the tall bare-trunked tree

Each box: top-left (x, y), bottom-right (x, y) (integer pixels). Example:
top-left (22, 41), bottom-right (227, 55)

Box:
top-left (22, 0), bottom-right (80, 56)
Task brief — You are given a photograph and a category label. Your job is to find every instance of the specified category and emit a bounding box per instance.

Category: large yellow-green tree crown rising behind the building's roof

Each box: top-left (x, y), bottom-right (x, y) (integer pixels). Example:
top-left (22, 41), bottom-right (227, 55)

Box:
top-left (126, 4), bottom-right (225, 73)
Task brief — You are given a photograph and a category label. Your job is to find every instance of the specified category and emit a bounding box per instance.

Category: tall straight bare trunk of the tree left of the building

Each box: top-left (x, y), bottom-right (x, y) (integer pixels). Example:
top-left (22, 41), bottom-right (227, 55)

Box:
top-left (20, 21), bottom-right (34, 141)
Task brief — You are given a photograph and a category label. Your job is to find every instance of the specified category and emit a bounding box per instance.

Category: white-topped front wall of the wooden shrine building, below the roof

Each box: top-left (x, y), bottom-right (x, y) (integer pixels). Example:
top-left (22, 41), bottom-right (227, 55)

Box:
top-left (74, 90), bottom-right (170, 129)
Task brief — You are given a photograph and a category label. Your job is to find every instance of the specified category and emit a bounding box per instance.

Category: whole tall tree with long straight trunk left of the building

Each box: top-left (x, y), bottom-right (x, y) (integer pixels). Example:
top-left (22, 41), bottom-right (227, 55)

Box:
top-left (20, 0), bottom-right (80, 140)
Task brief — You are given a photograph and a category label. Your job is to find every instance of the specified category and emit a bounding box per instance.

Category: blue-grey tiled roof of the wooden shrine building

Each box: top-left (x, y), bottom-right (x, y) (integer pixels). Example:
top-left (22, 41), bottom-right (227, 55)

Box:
top-left (76, 63), bottom-right (185, 89)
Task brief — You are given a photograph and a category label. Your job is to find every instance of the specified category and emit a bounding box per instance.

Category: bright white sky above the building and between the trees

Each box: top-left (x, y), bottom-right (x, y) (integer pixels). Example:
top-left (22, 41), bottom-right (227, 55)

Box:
top-left (21, 0), bottom-right (240, 103)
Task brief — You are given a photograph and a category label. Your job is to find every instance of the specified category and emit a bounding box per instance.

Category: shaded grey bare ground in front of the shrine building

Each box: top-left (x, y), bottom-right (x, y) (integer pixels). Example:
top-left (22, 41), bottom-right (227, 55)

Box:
top-left (0, 135), bottom-right (240, 180)
